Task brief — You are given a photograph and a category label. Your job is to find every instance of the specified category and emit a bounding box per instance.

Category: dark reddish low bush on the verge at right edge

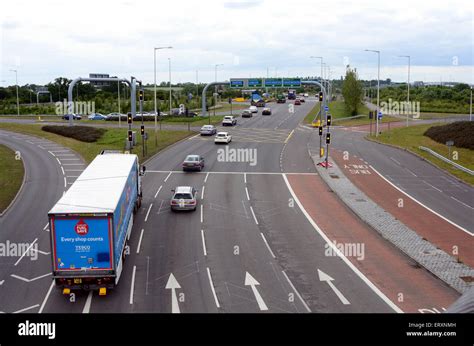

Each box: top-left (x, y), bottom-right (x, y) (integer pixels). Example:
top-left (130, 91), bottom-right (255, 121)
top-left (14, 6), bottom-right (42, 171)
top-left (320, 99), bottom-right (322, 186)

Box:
top-left (423, 121), bottom-right (474, 149)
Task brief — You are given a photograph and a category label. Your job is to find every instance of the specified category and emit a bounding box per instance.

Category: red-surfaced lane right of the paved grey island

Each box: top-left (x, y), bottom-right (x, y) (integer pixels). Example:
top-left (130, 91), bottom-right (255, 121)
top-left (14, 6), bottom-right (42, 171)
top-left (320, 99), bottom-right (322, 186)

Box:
top-left (331, 150), bottom-right (474, 267)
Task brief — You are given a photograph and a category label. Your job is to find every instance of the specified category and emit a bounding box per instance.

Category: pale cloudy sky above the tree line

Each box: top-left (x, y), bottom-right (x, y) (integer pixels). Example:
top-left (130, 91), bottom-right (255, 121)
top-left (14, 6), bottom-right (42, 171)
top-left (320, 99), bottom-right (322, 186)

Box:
top-left (0, 0), bottom-right (474, 86)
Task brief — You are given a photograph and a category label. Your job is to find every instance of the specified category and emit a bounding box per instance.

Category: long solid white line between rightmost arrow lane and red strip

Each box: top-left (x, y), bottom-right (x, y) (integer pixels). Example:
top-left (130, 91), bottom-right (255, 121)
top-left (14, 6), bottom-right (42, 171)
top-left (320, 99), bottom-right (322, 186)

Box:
top-left (283, 174), bottom-right (403, 313)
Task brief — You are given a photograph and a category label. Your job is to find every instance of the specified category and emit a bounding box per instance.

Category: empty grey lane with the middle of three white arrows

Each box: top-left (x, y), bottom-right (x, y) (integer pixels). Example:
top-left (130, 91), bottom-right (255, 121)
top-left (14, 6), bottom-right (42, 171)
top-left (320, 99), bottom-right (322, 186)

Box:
top-left (203, 174), bottom-right (304, 312)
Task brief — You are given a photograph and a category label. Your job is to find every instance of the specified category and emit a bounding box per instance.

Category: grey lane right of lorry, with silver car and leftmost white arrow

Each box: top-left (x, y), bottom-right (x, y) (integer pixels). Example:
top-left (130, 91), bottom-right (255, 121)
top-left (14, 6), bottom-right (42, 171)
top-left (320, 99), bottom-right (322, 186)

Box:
top-left (130, 174), bottom-right (217, 312)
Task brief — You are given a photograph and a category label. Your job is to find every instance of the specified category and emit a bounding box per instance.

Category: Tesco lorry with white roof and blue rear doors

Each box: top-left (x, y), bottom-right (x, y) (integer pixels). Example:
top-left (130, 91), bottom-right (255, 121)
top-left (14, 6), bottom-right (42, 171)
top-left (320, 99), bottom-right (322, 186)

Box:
top-left (48, 153), bottom-right (145, 295)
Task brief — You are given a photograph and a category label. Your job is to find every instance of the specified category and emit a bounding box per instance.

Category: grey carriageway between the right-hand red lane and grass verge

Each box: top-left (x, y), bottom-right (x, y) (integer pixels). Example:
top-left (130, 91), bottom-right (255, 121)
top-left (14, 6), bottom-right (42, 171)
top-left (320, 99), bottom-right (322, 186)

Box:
top-left (332, 131), bottom-right (474, 232)
